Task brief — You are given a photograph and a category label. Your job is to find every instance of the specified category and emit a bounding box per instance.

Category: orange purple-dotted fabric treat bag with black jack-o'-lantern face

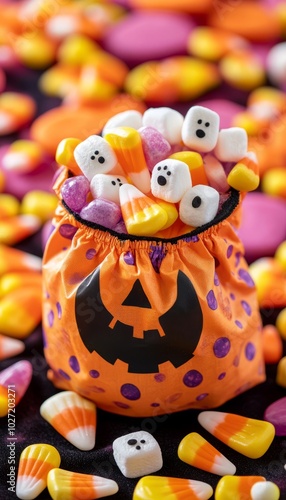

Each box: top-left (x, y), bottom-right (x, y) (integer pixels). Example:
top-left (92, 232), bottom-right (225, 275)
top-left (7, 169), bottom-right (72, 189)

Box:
top-left (43, 170), bottom-right (265, 417)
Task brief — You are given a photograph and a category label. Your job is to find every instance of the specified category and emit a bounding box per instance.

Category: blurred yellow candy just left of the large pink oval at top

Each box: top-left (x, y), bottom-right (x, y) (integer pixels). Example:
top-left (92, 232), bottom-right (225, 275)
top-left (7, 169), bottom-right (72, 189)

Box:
top-left (58, 34), bottom-right (99, 66)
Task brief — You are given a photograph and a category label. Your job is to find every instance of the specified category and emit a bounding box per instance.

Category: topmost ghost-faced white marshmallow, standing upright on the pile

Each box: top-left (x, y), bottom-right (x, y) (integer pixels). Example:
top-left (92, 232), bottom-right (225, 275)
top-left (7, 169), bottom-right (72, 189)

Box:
top-left (182, 106), bottom-right (220, 153)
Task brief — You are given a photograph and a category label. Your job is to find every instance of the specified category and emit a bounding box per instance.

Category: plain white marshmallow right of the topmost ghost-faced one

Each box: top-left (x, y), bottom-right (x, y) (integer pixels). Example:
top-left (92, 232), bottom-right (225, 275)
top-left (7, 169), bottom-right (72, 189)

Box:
top-left (214, 127), bottom-right (248, 162)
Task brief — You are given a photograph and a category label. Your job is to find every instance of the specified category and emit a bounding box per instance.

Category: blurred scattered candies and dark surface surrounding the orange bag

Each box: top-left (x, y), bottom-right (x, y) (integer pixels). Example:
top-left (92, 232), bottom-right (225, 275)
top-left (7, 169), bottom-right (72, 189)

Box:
top-left (0, 0), bottom-right (286, 500)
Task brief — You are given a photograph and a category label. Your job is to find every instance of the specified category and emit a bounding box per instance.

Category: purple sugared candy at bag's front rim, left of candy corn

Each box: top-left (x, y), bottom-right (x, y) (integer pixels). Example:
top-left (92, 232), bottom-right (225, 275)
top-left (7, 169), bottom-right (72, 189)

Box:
top-left (80, 198), bottom-right (122, 229)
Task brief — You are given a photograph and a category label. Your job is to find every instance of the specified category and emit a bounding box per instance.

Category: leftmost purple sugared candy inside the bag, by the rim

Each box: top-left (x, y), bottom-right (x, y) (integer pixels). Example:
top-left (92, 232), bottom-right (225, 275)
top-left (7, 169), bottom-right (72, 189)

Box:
top-left (61, 175), bottom-right (89, 212)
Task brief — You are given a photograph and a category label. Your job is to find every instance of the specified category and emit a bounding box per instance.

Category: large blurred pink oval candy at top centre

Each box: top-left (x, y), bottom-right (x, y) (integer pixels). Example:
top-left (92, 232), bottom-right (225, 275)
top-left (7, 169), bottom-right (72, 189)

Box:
top-left (103, 11), bottom-right (194, 66)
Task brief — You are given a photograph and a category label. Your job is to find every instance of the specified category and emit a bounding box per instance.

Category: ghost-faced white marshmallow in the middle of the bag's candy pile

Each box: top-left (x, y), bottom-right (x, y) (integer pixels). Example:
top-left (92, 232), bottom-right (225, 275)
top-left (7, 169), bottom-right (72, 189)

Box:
top-left (151, 158), bottom-right (192, 203)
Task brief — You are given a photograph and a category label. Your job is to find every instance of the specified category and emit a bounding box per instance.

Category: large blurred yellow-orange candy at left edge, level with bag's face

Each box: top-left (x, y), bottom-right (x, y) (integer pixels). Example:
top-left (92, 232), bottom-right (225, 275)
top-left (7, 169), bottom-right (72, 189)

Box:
top-left (0, 285), bottom-right (42, 339)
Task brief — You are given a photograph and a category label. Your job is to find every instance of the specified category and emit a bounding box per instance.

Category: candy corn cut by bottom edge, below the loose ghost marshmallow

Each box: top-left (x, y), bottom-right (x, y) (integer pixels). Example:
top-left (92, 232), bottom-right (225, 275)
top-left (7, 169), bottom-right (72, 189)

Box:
top-left (133, 476), bottom-right (213, 500)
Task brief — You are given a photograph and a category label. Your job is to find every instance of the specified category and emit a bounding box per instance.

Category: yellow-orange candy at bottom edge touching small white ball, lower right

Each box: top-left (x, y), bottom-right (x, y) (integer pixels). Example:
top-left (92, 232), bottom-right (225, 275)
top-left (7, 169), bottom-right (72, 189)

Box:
top-left (215, 476), bottom-right (266, 500)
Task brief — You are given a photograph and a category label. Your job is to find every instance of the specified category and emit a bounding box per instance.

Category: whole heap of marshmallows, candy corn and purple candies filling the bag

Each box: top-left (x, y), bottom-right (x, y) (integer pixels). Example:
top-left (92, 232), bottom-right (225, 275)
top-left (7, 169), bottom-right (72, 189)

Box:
top-left (56, 106), bottom-right (259, 237)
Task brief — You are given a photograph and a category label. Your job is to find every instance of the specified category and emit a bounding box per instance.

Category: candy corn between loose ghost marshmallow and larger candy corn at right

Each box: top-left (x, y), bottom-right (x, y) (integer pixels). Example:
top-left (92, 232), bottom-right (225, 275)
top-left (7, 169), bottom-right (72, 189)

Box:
top-left (178, 432), bottom-right (236, 476)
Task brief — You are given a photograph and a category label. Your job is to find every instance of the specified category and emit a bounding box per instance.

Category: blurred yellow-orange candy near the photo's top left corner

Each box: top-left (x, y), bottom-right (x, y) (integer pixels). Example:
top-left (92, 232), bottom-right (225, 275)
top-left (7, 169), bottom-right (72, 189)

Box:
top-left (14, 31), bottom-right (56, 69)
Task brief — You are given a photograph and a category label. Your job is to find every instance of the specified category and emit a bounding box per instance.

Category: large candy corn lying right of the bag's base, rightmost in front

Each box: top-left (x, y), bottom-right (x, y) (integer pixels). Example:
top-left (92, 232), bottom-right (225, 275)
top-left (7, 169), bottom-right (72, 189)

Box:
top-left (198, 411), bottom-right (275, 458)
